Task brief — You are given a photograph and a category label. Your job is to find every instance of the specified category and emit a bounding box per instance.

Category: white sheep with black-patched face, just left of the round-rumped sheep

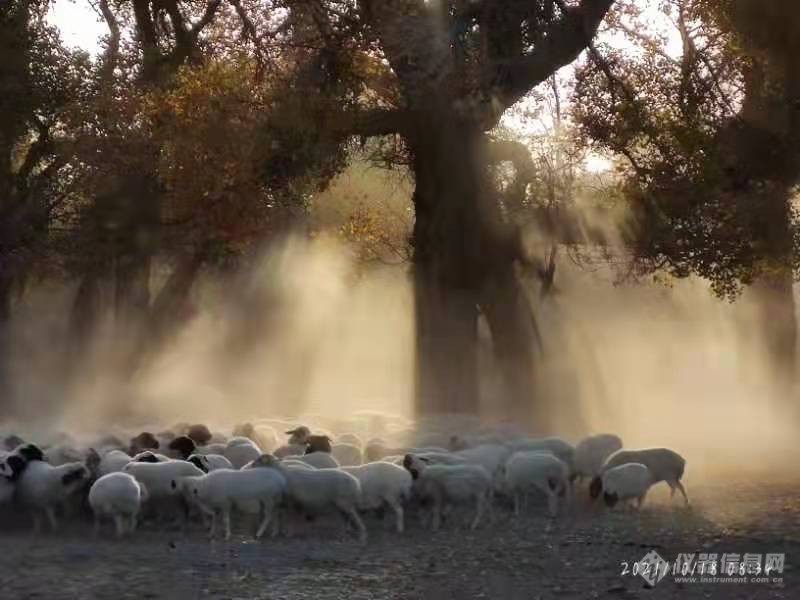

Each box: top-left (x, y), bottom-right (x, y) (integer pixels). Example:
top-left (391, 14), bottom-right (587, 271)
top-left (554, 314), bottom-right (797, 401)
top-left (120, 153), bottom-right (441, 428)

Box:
top-left (15, 460), bottom-right (91, 533)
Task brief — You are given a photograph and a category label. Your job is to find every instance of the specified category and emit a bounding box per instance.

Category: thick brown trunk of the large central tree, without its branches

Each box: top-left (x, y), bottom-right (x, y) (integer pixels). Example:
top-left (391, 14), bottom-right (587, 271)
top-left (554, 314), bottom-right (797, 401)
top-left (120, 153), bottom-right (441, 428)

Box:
top-left (408, 110), bottom-right (532, 416)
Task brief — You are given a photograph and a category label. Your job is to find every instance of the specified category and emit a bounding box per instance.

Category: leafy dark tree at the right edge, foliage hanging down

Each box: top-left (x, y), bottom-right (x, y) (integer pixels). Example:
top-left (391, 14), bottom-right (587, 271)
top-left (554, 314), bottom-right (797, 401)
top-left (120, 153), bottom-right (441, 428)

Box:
top-left (576, 0), bottom-right (800, 384)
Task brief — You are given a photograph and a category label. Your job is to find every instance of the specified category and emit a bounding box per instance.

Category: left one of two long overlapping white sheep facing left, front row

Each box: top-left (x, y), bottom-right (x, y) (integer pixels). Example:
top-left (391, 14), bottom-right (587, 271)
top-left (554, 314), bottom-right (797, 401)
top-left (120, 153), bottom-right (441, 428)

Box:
top-left (172, 468), bottom-right (287, 540)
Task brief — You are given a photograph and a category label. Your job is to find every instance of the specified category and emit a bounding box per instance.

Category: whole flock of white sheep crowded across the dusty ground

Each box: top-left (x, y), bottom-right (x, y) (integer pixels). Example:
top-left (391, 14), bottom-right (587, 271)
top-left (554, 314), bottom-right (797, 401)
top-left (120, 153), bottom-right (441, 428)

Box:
top-left (0, 411), bottom-right (689, 542)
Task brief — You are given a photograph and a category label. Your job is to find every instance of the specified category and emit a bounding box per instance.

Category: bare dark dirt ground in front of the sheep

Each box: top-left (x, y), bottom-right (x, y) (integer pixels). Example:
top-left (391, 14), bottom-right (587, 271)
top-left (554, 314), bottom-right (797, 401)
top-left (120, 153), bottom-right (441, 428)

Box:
top-left (0, 479), bottom-right (800, 600)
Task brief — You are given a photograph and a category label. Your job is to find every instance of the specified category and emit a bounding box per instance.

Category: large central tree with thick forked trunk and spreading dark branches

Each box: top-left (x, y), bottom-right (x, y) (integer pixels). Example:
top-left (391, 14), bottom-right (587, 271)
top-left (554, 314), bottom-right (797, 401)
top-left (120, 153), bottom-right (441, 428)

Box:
top-left (266, 0), bottom-right (613, 422)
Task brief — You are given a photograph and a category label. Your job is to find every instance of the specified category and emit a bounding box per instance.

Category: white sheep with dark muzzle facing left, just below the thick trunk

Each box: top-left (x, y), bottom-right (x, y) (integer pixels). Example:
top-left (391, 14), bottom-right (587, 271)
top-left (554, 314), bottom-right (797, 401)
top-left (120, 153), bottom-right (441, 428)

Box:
top-left (403, 454), bottom-right (492, 531)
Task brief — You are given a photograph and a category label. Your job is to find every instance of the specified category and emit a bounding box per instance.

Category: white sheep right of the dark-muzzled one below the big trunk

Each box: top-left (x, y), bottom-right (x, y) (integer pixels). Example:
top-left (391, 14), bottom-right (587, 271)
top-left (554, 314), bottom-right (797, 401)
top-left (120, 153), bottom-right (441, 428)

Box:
top-left (503, 451), bottom-right (570, 517)
